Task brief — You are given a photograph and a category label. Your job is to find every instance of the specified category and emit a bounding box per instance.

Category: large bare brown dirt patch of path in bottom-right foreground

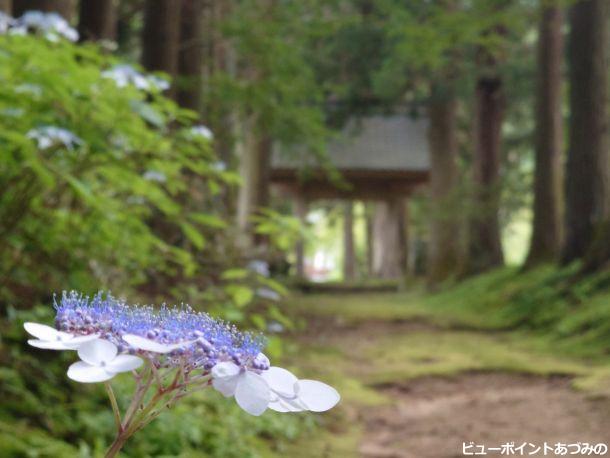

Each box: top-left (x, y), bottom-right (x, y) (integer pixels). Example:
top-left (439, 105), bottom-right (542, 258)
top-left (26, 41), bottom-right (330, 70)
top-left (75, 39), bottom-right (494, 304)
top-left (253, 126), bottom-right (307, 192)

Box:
top-left (360, 374), bottom-right (610, 458)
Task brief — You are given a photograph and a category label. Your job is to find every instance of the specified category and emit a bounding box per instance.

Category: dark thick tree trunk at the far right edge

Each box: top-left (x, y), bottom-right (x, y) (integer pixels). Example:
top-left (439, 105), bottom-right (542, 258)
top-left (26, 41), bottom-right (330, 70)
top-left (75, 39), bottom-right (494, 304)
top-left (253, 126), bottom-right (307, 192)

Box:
top-left (562, 0), bottom-right (610, 264)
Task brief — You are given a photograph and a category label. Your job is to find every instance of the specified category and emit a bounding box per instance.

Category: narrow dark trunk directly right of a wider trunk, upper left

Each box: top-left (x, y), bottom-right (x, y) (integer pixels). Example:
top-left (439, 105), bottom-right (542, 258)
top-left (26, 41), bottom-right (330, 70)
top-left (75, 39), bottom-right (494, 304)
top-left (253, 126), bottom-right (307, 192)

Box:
top-left (176, 0), bottom-right (204, 113)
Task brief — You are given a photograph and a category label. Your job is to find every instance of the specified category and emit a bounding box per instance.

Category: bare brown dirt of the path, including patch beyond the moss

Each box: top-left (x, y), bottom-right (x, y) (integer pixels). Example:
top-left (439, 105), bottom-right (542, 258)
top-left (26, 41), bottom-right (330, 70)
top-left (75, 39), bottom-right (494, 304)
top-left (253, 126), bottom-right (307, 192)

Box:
top-left (296, 317), bottom-right (610, 458)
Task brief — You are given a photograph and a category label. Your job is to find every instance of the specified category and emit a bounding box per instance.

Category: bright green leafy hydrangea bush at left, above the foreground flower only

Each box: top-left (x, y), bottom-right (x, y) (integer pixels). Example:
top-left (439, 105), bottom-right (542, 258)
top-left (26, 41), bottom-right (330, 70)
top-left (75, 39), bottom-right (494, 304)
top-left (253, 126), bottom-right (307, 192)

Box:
top-left (0, 35), bottom-right (230, 299)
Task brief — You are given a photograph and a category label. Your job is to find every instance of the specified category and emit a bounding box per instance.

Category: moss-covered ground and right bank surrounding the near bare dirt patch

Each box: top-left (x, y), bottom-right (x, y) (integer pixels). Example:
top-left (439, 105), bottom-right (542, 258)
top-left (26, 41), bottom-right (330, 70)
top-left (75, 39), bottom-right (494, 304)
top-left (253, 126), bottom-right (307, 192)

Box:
top-left (286, 269), bottom-right (610, 456)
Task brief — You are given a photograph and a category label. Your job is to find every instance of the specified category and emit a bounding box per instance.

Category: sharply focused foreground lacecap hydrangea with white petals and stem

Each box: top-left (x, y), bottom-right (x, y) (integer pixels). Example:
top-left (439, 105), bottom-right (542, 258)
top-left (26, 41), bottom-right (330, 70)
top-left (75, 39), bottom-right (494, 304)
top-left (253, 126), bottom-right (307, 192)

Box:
top-left (24, 292), bottom-right (340, 456)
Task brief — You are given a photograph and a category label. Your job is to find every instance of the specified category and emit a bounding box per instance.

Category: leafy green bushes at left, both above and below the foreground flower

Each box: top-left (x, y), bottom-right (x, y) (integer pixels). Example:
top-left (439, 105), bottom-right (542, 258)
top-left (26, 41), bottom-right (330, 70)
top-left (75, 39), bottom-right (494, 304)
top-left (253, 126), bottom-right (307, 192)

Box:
top-left (0, 25), bottom-right (300, 457)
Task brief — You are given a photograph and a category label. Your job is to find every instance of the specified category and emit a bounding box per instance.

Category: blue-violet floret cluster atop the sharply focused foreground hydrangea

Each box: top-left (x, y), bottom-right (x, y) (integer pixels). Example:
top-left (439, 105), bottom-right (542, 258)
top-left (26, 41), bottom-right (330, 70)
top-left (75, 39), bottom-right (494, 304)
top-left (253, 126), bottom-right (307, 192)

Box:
top-left (54, 291), bottom-right (268, 370)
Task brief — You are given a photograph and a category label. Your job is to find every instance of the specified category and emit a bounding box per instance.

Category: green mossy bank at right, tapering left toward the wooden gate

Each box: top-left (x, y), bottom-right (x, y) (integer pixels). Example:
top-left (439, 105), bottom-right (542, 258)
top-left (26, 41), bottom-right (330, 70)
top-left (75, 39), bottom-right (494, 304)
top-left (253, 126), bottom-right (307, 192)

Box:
top-left (291, 266), bottom-right (610, 361)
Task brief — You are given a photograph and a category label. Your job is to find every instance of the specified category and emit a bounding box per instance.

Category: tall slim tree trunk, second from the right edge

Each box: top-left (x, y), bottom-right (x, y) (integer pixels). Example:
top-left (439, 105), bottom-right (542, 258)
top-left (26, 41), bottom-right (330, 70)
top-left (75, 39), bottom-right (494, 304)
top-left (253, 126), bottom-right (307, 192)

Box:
top-left (526, 6), bottom-right (563, 266)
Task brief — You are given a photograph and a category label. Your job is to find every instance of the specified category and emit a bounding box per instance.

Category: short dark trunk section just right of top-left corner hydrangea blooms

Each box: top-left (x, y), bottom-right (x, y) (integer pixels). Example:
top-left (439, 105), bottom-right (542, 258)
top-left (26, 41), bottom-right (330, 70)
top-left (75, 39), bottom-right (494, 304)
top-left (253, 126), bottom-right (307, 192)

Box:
top-left (78, 0), bottom-right (117, 41)
